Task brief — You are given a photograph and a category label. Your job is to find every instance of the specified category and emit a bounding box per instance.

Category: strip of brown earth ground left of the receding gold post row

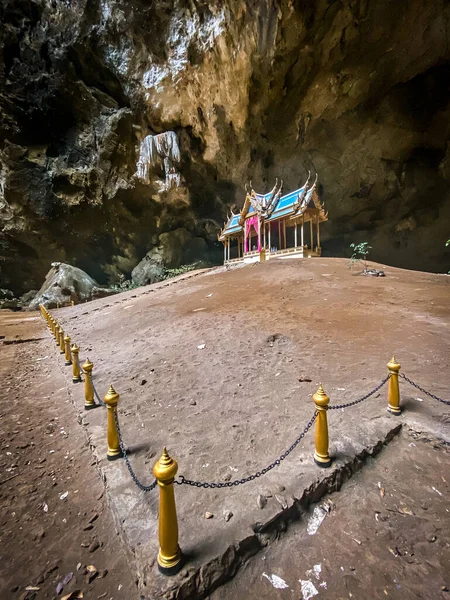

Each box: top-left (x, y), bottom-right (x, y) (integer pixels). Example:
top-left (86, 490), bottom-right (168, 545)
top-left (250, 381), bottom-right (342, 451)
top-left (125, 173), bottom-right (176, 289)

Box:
top-left (0, 311), bottom-right (137, 600)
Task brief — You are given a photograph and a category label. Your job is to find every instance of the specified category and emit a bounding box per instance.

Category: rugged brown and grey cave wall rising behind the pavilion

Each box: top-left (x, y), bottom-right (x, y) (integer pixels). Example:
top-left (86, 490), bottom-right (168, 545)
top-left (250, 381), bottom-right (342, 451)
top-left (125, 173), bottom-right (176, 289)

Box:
top-left (0, 0), bottom-right (450, 292)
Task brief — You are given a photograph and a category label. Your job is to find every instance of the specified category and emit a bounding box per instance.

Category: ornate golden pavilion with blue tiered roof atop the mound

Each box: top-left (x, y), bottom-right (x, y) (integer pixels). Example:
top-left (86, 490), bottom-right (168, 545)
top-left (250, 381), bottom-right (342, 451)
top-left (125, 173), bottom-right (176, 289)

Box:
top-left (218, 176), bottom-right (328, 264)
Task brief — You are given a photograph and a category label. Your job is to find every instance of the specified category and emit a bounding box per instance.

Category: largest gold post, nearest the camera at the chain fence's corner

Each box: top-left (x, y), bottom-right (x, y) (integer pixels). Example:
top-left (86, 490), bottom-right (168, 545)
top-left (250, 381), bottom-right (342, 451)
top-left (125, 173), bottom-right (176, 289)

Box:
top-left (153, 448), bottom-right (183, 575)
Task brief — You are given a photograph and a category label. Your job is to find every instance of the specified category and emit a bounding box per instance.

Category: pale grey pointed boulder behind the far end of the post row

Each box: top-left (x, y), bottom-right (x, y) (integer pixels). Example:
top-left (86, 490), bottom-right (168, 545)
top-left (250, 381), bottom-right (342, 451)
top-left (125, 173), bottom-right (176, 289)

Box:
top-left (29, 263), bottom-right (115, 310)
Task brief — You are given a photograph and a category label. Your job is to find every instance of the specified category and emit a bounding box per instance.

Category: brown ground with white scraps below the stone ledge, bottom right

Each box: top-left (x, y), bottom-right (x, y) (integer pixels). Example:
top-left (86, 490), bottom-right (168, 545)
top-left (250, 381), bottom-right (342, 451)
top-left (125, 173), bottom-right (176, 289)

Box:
top-left (211, 431), bottom-right (450, 600)
